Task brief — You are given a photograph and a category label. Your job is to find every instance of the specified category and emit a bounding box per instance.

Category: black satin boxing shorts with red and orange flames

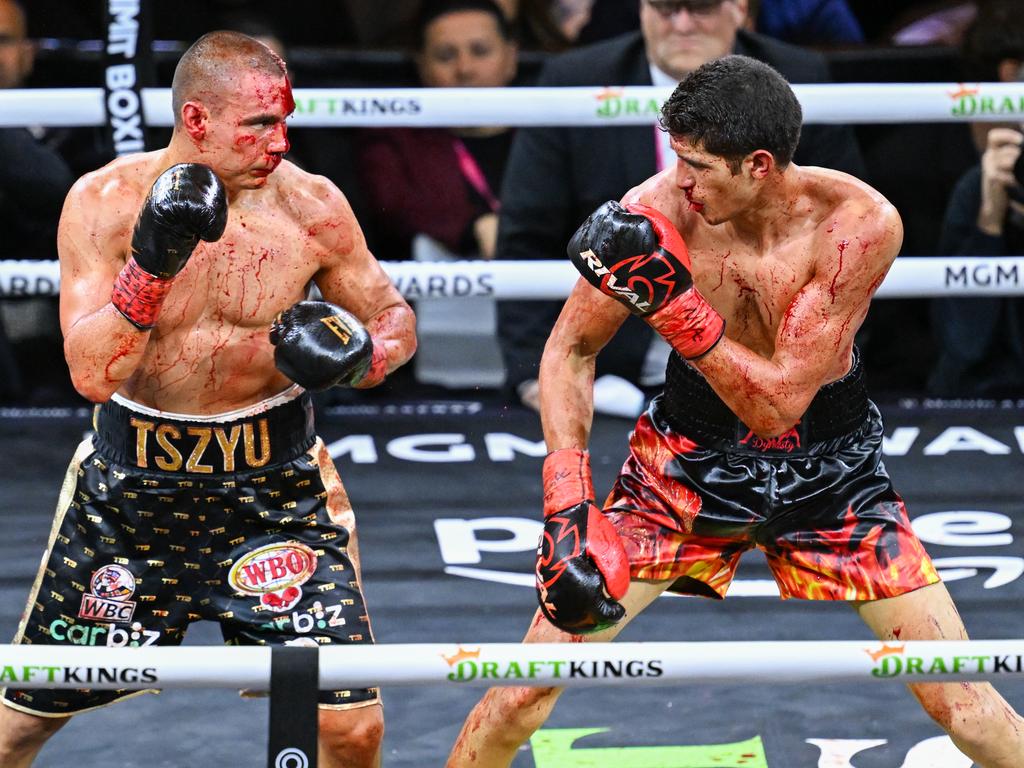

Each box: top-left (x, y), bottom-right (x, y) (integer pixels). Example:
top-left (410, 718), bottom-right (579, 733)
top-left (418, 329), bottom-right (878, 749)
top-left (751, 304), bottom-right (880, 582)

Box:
top-left (604, 354), bottom-right (939, 600)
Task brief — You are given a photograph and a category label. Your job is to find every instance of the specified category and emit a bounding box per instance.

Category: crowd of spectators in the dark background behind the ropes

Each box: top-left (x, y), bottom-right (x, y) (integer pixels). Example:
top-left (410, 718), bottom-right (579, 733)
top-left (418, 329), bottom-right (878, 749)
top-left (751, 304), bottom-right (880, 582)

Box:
top-left (0, 0), bottom-right (1024, 404)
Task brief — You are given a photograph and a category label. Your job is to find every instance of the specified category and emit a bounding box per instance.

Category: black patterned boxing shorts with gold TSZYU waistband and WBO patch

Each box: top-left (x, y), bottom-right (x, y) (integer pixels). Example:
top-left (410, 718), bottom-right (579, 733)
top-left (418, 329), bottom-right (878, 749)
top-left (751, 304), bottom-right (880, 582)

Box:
top-left (3, 387), bottom-right (378, 717)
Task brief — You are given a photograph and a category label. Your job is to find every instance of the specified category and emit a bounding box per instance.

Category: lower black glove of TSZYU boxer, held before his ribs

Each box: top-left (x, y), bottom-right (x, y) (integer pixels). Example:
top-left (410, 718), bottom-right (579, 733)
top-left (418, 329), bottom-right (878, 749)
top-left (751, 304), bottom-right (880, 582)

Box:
top-left (270, 301), bottom-right (387, 390)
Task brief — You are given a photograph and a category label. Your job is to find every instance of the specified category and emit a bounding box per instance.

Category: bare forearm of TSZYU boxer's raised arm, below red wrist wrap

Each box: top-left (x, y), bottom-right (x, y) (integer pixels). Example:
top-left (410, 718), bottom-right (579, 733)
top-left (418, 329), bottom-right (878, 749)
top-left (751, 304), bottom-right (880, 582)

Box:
top-left (65, 304), bottom-right (150, 402)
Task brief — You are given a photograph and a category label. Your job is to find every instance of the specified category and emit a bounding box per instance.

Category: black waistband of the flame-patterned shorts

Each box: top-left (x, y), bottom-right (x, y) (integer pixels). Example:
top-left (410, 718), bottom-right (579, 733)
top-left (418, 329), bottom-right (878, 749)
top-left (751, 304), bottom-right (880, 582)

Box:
top-left (654, 348), bottom-right (870, 454)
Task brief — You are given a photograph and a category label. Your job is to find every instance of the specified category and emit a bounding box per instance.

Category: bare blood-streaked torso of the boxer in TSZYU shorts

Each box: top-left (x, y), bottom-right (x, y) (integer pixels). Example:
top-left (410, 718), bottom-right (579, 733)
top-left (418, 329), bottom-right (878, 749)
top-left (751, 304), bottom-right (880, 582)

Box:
top-left (89, 154), bottom-right (338, 414)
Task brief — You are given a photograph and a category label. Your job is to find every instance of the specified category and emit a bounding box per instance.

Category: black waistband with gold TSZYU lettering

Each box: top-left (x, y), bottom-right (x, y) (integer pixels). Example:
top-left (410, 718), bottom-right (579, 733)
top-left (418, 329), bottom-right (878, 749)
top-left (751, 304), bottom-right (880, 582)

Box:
top-left (94, 392), bottom-right (315, 475)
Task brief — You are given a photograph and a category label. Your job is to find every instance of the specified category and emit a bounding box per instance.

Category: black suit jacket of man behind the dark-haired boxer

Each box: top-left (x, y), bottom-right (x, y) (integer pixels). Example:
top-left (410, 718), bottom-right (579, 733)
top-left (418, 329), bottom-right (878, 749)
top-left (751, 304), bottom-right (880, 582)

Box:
top-left (498, 31), bottom-right (864, 387)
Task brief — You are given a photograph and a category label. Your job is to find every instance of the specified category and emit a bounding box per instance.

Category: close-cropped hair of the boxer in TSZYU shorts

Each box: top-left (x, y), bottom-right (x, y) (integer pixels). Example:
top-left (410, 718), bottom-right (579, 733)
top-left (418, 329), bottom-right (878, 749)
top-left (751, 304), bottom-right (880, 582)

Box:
top-left (171, 31), bottom-right (288, 125)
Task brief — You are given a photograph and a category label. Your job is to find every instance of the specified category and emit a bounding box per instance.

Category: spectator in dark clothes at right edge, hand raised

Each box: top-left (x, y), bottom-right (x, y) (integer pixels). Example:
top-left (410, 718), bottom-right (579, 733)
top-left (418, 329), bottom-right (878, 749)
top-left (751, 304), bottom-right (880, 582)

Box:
top-left (929, 0), bottom-right (1024, 397)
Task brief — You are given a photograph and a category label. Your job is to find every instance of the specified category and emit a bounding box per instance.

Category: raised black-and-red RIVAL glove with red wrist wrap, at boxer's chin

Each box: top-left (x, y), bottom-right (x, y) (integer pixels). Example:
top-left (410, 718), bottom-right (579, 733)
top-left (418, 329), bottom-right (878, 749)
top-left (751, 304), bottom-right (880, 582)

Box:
top-left (568, 201), bottom-right (725, 359)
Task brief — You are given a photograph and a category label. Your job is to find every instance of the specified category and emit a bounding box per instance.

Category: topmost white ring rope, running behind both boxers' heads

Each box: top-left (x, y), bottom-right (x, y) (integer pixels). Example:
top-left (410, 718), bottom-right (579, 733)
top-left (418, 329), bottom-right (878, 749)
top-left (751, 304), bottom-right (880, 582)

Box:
top-left (0, 83), bottom-right (1024, 127)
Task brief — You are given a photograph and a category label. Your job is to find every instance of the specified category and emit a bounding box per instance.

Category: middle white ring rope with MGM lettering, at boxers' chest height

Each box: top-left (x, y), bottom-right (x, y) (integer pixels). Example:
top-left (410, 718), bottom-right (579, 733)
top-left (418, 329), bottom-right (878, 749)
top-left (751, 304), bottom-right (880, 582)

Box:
top-left (0, 256), bottom-right (1024, 300)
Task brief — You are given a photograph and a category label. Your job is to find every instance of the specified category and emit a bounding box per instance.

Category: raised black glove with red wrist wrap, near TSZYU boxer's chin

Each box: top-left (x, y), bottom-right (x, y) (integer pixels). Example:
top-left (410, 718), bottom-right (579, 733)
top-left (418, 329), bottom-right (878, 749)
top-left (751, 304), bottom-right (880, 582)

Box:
top-left (111, 163), bottom-right (227, 331)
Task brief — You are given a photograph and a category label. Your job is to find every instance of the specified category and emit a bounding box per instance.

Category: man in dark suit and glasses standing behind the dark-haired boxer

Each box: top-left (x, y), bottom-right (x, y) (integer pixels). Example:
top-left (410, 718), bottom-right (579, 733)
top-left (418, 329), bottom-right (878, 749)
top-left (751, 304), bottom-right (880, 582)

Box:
top-left (497, 0), bottom-right (863, 407)
